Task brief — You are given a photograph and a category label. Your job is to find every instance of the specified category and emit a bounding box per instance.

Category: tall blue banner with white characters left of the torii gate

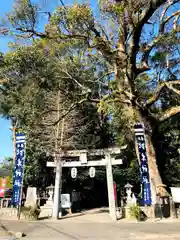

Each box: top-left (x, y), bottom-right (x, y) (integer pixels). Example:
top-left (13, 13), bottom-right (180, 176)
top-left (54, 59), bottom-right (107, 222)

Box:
top-left (12, 133), bottom-right (25, 207)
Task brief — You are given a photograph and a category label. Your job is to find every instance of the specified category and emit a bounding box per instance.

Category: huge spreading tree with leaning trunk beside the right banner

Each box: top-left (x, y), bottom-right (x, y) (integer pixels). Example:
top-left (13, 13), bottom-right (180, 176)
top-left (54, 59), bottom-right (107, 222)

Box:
top-left (2, 0), bottom-right (180, 199)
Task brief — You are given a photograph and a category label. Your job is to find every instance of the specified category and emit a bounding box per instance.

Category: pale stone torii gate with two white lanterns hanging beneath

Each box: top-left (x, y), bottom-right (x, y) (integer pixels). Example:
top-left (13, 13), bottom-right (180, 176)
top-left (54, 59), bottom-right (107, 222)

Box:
top-left (47, 146), bottom-right (126, 220)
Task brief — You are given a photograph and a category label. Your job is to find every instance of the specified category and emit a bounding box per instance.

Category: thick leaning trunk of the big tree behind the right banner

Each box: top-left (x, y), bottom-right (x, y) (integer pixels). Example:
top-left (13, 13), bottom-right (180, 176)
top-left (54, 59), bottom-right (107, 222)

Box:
top-left (114, 37), bottom-right (167, 203)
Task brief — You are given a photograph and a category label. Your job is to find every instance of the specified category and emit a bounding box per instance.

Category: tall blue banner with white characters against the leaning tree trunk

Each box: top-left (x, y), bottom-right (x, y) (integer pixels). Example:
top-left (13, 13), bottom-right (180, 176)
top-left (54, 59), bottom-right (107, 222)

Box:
top-left (135, 123), bottom-right (152, 205)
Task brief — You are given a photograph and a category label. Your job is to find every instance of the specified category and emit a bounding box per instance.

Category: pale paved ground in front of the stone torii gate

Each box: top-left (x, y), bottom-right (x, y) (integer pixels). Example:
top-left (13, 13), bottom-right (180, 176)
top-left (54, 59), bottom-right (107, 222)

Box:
top-left (1, 213), bottom-right (180, 240)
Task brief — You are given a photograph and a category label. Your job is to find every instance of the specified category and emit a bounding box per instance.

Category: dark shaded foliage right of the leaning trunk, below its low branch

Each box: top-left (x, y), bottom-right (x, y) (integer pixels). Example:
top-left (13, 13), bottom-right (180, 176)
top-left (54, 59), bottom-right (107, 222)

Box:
top-left (154, 111), bottom-right (180, 186)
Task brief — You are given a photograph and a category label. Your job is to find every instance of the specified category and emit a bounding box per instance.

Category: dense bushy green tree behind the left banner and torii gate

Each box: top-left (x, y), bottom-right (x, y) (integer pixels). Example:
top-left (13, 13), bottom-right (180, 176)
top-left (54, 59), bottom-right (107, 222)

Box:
top-left (0, 36), bottom-right (112, 187)
